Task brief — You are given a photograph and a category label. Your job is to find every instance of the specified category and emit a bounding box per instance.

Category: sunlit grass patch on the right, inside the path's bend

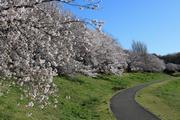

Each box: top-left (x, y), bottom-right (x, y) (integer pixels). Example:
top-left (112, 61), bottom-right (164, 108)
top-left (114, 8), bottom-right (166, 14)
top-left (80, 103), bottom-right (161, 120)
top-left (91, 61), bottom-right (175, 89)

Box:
top-left (136, 78), bottom-right (180, 120)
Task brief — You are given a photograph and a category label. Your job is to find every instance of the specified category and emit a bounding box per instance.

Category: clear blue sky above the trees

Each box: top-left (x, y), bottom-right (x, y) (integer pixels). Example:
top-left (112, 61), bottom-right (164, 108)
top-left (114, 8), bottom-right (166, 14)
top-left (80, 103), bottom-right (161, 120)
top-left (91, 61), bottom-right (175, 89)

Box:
top-left (62, 0), bottom-right (180, 55)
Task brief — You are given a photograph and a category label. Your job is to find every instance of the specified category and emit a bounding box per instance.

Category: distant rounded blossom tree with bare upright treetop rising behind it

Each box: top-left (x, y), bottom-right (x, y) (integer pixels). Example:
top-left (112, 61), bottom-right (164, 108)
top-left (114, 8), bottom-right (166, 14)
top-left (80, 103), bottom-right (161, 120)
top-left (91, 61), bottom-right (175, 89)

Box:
top-left (127, 41), bottom-right (165, 72)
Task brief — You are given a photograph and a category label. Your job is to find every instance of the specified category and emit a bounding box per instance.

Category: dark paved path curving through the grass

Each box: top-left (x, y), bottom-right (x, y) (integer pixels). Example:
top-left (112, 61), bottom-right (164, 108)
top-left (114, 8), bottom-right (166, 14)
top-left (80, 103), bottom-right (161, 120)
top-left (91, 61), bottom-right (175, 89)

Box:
top-left (110, 81), bottom-right (160, 120)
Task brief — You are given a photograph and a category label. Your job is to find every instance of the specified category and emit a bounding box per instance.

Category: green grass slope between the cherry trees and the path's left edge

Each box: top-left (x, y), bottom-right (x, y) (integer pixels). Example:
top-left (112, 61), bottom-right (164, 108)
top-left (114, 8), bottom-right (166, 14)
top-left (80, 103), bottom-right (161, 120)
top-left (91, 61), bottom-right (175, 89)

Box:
top-left (0, 73), bottom-right (170, 120)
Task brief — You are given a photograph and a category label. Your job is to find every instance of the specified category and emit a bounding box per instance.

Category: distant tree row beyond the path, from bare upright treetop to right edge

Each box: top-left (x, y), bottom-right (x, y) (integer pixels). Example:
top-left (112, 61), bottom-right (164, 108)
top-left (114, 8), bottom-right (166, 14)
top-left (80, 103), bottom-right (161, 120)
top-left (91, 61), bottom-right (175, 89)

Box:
top-left (127, 41), bottom-right (180, 73)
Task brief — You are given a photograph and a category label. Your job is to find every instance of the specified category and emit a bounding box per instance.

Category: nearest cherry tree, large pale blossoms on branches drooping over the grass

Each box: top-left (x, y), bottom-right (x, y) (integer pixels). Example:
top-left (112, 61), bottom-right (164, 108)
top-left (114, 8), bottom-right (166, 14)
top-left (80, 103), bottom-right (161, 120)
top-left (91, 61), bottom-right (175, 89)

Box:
top-left (0, 0), bottom-right (102, 102)
